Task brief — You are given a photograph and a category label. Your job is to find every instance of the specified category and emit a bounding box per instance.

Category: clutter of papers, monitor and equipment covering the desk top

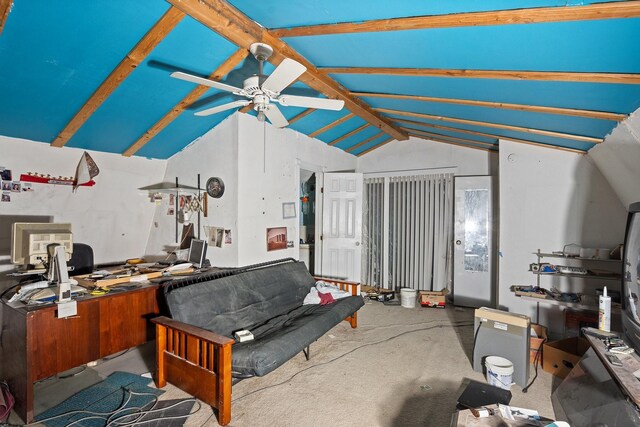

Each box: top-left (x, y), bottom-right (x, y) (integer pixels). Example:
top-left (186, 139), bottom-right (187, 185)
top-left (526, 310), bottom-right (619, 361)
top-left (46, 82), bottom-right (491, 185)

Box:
top-left (0, 223), bottom-right (210, 315)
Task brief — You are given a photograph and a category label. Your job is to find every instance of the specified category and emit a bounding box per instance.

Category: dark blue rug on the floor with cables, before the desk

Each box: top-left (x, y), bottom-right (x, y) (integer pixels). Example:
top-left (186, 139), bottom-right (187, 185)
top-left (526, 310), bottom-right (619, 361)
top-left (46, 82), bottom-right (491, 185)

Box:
top-left (35, 372), bottom-right (164, 427)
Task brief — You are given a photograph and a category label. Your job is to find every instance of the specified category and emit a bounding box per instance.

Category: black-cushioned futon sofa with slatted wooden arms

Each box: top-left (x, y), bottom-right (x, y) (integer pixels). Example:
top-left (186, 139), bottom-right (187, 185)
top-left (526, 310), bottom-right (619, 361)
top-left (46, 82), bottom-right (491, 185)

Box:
top-left (153, 259), bottom-right (364, 425)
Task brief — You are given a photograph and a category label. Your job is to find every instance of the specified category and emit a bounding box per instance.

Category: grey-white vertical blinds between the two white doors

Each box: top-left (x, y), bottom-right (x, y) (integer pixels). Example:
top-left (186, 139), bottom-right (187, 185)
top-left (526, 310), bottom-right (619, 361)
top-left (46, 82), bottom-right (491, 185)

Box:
top-left (363, 174), bottom-right (453, 290)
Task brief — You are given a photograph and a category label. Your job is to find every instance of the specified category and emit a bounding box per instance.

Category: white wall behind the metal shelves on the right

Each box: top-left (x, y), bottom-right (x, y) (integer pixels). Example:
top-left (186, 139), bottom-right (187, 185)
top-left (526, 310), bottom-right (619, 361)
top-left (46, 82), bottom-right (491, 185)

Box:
top-left (499, 140), bottom-right (627, 335)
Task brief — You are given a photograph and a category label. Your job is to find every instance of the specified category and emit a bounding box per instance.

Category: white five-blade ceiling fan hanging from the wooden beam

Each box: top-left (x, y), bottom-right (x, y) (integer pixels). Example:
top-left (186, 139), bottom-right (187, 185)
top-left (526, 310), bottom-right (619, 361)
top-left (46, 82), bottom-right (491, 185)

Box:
top-left (171, 43), bottom-right (344, 128)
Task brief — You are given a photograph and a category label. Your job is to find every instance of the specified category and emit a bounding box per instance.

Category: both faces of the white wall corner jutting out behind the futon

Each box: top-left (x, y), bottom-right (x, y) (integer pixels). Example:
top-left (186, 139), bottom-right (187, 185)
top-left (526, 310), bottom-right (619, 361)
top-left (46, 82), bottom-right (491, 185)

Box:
top-left (147, 113), bottom-right (356, 266)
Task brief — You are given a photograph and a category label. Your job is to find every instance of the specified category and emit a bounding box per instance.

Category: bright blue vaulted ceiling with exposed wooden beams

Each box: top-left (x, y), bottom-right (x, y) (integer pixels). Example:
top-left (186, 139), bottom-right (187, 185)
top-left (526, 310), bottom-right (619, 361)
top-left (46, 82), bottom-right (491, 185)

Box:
top-left (0, 0), bottom-right (640, 158)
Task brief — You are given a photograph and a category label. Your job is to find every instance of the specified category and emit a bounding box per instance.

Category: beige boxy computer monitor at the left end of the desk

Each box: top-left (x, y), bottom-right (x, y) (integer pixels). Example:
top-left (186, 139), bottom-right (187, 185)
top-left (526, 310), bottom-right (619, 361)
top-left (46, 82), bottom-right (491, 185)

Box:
top-left (11, 222), bottom-right (73, 269)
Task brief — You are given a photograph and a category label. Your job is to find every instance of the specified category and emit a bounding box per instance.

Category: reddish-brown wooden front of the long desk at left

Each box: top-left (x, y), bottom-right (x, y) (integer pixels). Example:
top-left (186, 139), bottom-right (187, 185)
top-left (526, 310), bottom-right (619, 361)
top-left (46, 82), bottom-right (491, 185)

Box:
top-left (0, 284), bottom-right (161, 423)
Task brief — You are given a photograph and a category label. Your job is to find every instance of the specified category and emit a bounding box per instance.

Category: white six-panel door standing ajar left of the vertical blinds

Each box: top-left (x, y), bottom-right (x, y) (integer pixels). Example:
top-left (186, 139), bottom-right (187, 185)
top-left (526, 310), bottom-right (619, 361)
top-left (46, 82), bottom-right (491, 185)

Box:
top-left (321, 173), bottom-right (362, 282)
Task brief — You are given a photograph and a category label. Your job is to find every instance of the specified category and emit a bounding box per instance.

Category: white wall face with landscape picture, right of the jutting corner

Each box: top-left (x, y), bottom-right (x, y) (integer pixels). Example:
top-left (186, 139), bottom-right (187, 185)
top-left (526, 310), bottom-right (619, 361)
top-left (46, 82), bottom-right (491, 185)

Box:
top-left (238, 114), bottom-right (356, 264)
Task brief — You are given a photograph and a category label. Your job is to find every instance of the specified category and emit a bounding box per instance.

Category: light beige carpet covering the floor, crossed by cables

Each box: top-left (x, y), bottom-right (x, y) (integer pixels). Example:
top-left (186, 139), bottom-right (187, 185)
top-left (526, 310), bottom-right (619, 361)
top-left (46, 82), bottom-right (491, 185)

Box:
top-left (20, 301), bottom-right (554, 427)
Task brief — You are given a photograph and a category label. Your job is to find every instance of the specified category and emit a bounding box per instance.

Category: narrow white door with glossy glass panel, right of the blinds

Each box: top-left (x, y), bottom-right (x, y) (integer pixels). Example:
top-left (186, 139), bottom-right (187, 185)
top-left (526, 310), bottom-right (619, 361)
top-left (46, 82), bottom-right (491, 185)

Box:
top-left (453, 176), bottom-right (494, 307)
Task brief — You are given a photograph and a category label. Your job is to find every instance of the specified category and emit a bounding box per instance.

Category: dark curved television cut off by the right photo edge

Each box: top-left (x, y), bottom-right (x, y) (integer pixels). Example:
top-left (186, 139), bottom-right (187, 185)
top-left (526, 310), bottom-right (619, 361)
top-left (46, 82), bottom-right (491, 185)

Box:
top-left (621, 202), bottom-right (640, 353)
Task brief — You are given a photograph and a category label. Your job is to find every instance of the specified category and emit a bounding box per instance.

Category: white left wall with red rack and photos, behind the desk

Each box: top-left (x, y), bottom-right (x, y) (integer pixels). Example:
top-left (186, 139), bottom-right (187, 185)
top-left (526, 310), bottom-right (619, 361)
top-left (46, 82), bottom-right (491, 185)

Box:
top-left (0, 136), bottom-right (166, 263)
